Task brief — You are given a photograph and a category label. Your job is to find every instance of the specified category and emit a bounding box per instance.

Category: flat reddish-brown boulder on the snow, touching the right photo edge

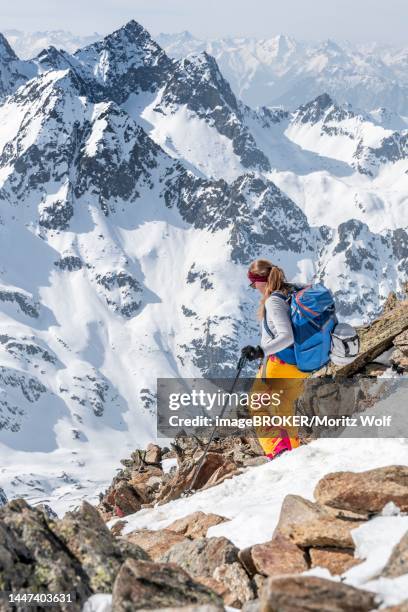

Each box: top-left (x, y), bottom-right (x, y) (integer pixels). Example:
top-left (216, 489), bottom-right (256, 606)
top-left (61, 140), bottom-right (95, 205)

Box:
top-left (314, 465), bottom-right (408, 513)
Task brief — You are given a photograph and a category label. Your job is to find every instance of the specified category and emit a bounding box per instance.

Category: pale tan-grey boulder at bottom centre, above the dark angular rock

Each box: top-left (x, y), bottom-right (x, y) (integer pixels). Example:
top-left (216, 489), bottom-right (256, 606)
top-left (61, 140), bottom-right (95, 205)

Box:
top-left (160, 537), bottom-right (238, 578)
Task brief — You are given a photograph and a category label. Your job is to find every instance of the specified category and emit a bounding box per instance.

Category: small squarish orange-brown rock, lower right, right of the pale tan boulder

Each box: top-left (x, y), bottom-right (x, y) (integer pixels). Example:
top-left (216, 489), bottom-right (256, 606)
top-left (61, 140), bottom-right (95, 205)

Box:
top-left (251, 534), bottom-right (308, 576)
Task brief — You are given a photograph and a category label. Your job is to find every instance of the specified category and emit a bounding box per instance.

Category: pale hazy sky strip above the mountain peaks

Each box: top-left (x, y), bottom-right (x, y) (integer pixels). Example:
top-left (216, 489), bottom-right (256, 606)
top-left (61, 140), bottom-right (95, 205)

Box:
top-left (0, 0), bottom-right (408, 44)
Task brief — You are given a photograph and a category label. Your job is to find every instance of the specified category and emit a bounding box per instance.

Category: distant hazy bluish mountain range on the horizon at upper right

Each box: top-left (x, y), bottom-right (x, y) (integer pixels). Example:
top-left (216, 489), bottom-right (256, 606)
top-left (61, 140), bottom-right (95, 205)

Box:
top-left (157, 32), bottom-right (408, 115)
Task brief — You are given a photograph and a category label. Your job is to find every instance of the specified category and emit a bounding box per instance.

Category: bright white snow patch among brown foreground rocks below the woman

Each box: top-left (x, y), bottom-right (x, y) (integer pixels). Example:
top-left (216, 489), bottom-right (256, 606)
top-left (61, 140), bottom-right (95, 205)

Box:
top-left (112, 439), bottom-right (408, 605)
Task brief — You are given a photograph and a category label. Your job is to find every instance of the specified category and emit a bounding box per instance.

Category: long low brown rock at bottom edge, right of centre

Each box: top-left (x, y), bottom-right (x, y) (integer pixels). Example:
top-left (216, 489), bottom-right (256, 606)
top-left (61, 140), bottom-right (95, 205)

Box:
top-left (261, 576), bottom-right (378, 612)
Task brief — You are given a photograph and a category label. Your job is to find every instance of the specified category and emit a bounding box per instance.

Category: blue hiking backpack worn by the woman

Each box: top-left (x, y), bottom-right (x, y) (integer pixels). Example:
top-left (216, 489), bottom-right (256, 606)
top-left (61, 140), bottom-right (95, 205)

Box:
top-left (264, 283), bottom-right (337, 372)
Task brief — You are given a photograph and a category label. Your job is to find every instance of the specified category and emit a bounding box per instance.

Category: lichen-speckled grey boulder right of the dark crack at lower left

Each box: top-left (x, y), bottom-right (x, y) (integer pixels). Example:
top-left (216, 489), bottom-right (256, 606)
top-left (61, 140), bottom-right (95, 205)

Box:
top-left (52, 502), bottom-right (149, 593)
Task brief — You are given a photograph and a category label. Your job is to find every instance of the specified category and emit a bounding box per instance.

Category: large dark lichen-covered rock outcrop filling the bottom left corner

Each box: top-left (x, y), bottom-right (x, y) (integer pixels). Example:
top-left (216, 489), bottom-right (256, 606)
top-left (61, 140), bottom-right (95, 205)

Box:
top-left (0, 500), bottom-right (149, 611)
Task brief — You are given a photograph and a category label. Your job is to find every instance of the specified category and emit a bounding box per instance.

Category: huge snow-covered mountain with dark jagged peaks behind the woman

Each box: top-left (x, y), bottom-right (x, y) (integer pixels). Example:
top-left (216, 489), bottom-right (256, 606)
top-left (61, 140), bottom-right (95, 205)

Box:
top-left (0, 22), bottom-right (408, 509)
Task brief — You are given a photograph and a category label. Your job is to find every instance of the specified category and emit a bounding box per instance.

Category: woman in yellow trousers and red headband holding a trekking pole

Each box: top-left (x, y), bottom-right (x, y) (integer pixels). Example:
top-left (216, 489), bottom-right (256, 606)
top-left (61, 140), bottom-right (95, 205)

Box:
top-left (242, 259), bottom-right (308, 459)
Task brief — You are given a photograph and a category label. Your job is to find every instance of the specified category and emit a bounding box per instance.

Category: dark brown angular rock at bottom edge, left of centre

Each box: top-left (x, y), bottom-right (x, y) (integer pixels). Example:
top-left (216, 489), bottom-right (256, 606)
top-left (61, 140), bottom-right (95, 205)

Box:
top-left (112, 559), bottom-right (223, 612)
